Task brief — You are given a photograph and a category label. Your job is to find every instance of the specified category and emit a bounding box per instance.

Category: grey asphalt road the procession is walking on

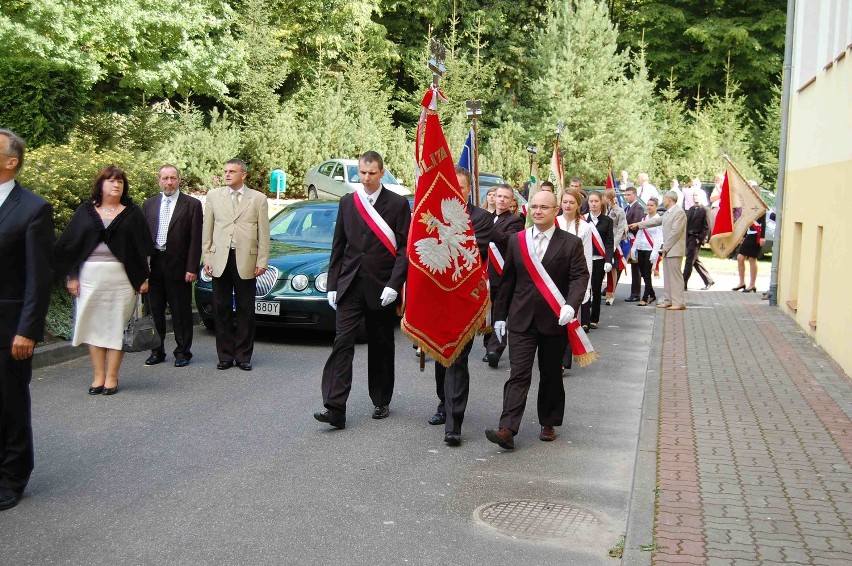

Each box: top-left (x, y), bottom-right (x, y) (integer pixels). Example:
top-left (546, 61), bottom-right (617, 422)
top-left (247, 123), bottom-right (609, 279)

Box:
top-left (0, 285), bottom-right (655, 566)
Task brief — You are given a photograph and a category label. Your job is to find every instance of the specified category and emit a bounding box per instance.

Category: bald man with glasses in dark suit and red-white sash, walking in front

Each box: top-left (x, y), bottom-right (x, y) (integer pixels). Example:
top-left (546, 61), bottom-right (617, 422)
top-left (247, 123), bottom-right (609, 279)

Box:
top-left (485, 192), bottom-right (589, 449)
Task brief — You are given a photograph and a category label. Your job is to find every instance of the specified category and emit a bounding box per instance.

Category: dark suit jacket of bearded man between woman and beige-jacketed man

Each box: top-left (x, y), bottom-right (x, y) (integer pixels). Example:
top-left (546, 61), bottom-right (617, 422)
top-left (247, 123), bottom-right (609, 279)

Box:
top-left (142, 192), bottom-right (204, 281)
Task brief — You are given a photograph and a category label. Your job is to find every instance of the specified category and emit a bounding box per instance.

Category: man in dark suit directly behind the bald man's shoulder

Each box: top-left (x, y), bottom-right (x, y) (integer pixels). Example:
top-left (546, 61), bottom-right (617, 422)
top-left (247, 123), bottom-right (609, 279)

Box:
top-left (482, 185), bottom-right (524, 368)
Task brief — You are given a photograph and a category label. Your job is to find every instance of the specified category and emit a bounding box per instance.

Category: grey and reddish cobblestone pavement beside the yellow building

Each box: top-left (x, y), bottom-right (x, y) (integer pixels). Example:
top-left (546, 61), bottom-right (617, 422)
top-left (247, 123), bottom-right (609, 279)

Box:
top-left (652, 292), bottom-right (852, 566)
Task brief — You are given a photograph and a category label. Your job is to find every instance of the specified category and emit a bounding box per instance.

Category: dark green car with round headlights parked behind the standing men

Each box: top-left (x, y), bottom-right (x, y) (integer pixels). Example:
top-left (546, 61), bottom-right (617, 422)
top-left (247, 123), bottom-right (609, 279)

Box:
top-left (195, 200), bottom-right (339, 331)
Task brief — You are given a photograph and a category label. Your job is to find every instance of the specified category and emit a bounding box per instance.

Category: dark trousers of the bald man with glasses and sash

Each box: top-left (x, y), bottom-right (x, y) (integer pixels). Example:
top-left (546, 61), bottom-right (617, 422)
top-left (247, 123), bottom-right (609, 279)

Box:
top-left (500, 323), bottom-right (568, 434)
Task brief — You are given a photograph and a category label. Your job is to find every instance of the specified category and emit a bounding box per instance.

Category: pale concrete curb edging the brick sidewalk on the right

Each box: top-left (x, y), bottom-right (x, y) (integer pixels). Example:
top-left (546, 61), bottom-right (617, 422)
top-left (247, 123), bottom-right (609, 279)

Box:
top-left (621, 309), bottom-right (666, 566)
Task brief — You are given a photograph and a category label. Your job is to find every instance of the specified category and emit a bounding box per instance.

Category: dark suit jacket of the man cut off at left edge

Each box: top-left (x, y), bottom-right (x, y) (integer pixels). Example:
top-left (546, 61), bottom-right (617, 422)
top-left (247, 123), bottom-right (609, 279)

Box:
top-left (0, 182), bottom-right (55, 349)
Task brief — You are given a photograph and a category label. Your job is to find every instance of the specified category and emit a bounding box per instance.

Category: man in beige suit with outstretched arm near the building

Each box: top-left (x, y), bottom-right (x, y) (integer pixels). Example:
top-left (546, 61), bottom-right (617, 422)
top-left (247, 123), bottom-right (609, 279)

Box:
top-left (630, 191), bottom-right (686, 311)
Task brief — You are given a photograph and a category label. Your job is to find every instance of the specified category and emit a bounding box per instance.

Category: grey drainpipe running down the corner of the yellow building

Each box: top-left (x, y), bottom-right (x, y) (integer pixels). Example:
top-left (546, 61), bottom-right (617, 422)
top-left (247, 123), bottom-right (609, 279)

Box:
top-left (769, 0), bottom-right (796, 307)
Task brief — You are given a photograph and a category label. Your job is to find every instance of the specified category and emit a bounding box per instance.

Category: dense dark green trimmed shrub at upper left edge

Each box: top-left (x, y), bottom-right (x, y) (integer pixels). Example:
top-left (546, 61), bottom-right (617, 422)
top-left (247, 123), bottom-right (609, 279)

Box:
top-left (0, 59), bottom-right (87, 147)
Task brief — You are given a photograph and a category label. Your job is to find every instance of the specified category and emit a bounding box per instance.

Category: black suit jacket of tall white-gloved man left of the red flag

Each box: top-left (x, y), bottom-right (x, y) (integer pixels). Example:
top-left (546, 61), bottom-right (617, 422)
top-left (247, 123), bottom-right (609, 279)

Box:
top-left (328, 187), bottom-right (411, 309)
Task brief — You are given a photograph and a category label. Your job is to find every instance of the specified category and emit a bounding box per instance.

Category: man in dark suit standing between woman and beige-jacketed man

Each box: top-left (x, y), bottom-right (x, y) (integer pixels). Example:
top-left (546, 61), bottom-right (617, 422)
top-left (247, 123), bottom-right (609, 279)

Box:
top-left (142, 165), bottom-right (204, 367)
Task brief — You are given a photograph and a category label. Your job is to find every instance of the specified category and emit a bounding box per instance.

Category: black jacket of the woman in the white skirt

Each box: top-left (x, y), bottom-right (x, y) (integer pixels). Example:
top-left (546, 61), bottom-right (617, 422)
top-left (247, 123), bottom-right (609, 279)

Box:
top-left (55, 202), bottom-right (154, 290)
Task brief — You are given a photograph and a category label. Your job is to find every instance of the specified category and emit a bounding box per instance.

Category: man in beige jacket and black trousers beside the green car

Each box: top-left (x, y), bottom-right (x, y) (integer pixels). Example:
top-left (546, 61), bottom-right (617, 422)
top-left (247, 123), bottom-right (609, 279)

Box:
top-left (201, 159), bottom-right (269, 371)
